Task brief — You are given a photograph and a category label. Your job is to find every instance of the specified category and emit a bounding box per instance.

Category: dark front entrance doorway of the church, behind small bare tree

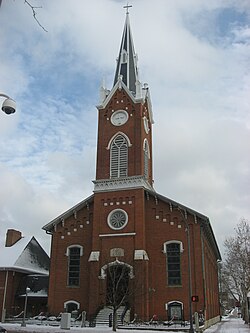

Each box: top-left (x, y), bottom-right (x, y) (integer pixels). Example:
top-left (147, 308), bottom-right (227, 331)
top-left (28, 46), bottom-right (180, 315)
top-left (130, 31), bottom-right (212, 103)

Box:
top-left (106, 263), bottom-right (130, 306)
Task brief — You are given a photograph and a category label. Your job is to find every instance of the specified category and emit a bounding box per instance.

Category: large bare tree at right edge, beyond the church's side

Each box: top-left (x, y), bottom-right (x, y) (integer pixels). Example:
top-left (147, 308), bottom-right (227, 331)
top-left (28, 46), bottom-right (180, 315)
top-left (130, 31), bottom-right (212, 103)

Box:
top-left (221, 218), bottom-right (250, 323)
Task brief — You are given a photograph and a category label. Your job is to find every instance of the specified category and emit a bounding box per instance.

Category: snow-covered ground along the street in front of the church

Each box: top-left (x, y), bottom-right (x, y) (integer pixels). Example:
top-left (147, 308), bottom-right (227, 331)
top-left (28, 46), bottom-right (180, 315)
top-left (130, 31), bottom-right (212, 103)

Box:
top-left (1, 316), bottom-right (250, 333)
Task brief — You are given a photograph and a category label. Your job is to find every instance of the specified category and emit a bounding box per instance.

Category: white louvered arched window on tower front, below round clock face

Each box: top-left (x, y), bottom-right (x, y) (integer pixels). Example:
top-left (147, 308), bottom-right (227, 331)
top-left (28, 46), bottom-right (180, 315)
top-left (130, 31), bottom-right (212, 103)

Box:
top-left (110, 134), bottom-right (128, 178)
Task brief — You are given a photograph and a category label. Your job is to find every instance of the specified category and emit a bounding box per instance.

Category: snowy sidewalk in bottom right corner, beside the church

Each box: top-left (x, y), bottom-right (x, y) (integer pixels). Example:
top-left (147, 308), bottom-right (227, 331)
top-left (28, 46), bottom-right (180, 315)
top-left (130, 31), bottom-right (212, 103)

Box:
top-left (205, 316), bottom-right (250, 333)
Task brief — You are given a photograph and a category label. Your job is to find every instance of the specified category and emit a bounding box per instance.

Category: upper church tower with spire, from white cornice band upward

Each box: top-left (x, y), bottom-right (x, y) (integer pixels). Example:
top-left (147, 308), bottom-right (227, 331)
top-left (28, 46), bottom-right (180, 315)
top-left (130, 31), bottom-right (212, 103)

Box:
top-left (94, 11), bottom-right (153, 192)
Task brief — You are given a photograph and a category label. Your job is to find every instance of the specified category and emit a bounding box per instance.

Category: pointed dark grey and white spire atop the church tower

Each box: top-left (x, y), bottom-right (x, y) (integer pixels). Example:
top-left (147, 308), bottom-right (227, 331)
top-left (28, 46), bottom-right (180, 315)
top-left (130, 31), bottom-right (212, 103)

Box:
top-left (114, 5), bottom-right (138, 94)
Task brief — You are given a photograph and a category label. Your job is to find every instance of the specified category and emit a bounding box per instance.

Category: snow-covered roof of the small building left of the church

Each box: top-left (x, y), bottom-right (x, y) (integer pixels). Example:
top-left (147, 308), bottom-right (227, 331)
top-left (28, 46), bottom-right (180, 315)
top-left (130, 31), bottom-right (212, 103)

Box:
top-left (0, 237), bottom-right (49, 275)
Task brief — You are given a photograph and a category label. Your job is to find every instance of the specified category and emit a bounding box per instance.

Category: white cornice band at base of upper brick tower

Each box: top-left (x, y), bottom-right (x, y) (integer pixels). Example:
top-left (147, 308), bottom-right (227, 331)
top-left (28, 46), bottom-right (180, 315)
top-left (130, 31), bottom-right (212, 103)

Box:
top-left (93, 176), bottom-right (154, 192)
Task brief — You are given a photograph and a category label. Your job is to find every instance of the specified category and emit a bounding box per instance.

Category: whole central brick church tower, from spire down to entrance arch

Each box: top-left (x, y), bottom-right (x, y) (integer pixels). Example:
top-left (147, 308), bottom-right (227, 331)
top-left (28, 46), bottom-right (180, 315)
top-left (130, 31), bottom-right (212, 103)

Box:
top-left (89, 12), bottom-right (154, 315)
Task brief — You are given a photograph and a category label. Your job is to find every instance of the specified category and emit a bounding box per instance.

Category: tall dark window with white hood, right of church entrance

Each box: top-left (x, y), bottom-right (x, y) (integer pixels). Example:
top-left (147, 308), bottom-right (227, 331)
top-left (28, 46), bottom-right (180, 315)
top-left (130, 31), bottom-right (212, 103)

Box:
top-left (164, 241), bottom-right (183, 286)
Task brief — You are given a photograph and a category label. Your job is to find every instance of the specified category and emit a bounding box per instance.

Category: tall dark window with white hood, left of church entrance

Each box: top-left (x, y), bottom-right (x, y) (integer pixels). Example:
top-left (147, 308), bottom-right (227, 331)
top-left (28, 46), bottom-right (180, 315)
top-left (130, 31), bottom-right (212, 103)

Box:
top-left (66, 245), bottom-right (83, 286)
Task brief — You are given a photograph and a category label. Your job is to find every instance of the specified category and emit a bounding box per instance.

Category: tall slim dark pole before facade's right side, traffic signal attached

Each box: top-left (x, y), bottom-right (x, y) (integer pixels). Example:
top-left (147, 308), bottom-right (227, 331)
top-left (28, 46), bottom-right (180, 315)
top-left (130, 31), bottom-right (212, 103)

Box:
top-left (177, 207), bottom-right (194, 333)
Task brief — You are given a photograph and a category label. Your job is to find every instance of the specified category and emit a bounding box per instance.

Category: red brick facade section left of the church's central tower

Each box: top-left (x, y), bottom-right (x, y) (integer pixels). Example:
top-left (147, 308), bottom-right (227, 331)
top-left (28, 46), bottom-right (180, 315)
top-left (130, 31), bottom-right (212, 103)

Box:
top-left (48, 201), bottom-right (93, 315)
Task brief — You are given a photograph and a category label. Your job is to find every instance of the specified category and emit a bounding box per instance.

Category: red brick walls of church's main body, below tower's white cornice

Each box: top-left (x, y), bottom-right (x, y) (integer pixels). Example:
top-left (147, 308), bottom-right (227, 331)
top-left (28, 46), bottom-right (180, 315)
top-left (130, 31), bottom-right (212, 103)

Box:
top-left (46, 189), bottom-right (219, 320)
